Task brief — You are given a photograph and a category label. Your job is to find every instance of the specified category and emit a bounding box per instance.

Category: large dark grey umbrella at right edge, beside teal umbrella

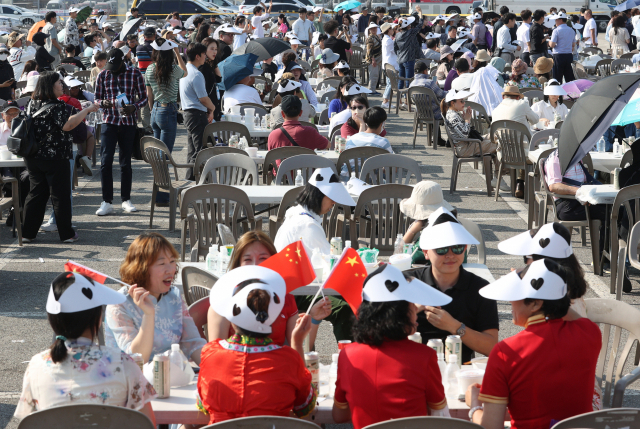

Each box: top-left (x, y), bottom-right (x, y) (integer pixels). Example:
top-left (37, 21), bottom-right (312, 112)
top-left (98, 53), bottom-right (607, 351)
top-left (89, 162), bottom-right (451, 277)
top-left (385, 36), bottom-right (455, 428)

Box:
top-left (558, 73), bottom-right (640, 174)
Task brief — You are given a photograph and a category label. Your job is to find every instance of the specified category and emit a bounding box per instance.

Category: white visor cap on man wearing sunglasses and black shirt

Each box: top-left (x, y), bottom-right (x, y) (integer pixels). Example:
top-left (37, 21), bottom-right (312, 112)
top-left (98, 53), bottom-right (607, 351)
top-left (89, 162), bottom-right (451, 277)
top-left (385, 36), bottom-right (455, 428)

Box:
top-left (420, 207), bottom-right (478, 250)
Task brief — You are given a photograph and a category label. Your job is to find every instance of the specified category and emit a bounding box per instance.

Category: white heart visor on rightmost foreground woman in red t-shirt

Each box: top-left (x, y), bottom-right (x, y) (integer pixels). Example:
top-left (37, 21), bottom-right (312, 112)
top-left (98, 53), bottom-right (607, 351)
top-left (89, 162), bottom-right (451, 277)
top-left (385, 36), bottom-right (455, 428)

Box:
top-left (479, 259), bottom-right (567, 301)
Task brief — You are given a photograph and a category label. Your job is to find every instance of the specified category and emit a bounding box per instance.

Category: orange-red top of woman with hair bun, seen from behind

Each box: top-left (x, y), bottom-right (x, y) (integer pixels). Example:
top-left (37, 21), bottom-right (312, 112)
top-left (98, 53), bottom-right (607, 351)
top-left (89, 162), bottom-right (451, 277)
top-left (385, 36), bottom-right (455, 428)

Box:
top-left (198, 336), bottom-right (316, 424)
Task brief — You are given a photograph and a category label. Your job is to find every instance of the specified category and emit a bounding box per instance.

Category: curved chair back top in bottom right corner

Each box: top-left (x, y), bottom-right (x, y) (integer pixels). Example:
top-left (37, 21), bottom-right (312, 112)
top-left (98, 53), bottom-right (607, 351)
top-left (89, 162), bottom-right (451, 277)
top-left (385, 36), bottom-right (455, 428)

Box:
top-left (551, 408), bottom-right (640, 429)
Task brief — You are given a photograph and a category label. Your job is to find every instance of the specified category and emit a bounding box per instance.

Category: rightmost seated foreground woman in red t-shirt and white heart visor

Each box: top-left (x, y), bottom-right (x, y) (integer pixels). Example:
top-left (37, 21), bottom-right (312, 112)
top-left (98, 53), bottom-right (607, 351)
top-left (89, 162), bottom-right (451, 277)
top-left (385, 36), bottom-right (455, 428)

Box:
top-left (467, 259), bottom-right (602, 429)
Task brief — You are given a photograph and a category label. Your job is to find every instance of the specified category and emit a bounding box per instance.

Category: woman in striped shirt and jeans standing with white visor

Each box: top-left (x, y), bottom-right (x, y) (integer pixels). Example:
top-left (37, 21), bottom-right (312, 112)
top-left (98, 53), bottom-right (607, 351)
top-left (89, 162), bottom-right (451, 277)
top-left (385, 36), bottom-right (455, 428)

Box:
top-left (145, 38), bottom-right (187, 206)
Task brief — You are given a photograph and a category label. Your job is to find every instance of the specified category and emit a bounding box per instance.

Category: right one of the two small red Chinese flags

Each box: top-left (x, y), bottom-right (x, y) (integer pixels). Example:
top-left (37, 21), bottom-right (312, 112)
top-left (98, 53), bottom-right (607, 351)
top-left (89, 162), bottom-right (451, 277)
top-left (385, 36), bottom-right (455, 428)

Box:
top-left (323, 247), bottom-right (367, 314)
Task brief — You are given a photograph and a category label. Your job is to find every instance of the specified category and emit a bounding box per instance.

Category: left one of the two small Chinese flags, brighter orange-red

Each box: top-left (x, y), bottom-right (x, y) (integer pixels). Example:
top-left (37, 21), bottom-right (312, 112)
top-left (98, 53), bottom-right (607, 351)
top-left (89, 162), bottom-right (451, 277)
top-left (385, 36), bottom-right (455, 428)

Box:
top-left (260, 241), bottom-right (316, 293)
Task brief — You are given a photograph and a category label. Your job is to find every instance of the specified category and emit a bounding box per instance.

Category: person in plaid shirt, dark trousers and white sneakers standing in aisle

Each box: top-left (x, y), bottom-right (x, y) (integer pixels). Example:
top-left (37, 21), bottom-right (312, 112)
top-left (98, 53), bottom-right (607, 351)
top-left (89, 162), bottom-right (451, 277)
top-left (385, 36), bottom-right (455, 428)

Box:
top-left (95, 49), bottom-right (147, 216)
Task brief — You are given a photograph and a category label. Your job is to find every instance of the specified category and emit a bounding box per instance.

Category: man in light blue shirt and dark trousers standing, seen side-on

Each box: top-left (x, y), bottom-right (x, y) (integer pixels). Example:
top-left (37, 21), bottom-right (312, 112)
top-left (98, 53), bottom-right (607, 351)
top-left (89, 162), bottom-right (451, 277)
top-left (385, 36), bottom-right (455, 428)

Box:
top-left (180, 43), bottom-right (216, 180)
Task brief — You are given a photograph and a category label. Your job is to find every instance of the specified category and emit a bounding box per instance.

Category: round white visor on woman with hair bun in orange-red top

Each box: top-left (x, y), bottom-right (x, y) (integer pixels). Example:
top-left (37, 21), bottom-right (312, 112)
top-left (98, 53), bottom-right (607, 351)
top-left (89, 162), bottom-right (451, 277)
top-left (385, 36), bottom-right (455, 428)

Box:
top-left (209, 265), bottom-right (287, 334)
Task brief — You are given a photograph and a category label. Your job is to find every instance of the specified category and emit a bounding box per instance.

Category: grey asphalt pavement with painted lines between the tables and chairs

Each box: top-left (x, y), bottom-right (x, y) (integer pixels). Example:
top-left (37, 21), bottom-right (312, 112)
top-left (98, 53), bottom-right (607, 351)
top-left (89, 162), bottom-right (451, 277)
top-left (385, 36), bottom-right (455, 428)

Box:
top-left (0, 34), bottom-right (640, 429)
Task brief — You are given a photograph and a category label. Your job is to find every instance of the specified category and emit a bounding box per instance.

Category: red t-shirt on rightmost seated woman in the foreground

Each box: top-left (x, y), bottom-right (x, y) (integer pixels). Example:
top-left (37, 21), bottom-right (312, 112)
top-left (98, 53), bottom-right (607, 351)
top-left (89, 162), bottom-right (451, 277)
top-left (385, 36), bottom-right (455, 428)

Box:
top-left (480, 315), bottom-right (602, 429)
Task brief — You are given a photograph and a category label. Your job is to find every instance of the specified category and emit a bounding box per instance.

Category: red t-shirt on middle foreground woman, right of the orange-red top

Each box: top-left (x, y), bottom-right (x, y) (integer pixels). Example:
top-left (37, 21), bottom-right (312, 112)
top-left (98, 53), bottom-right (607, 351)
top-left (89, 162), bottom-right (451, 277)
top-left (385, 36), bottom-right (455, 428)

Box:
top-left (334, 339), bottom-right (447, 429)
